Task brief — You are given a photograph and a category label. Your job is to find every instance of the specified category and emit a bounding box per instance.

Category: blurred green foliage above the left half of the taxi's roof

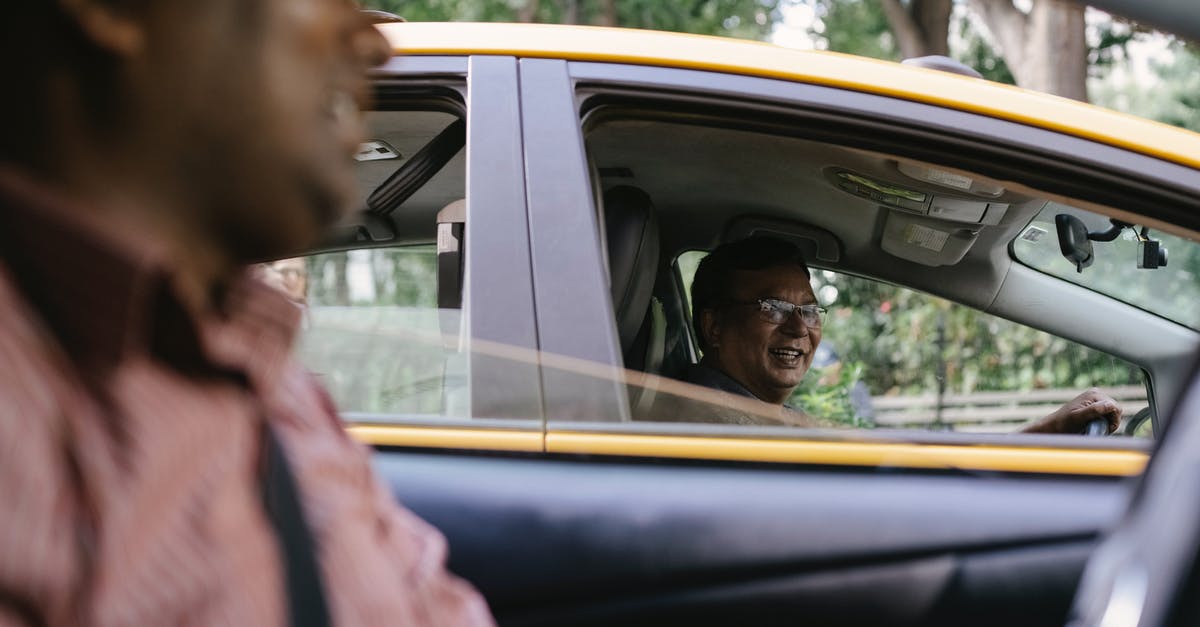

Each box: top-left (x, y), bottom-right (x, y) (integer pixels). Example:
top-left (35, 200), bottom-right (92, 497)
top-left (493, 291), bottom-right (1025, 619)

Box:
top-left (362, 0), bottom-right (780, 40)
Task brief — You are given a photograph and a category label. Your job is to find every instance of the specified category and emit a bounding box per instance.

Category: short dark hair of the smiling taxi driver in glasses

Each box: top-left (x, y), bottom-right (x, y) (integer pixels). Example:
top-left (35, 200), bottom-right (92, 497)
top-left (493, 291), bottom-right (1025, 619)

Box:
top-left (691, 235), bottom-right (812, 352)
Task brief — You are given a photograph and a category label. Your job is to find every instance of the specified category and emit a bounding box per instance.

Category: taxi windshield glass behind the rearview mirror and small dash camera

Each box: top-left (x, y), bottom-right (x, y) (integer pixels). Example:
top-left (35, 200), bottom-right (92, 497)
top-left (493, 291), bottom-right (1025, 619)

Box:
top-left (1012, 202), bottom-right (1200, 330)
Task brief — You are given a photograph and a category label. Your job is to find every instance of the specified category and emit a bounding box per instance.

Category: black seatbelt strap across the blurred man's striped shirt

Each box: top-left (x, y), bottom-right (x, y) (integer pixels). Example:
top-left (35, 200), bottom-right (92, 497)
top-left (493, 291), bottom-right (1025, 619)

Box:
top-left (262, 426), bottom-right (331, 627)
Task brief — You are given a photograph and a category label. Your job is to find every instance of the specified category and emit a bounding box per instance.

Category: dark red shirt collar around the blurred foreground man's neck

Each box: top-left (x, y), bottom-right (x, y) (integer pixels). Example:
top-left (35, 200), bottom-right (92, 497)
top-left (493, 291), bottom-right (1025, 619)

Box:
top-left (0, 166), bottom-right (300, 378)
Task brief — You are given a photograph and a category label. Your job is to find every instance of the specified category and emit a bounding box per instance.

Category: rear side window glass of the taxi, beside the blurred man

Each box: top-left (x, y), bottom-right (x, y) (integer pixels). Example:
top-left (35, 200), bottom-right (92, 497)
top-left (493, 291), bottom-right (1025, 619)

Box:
top-left (280, 111), bottom-right (470, 423)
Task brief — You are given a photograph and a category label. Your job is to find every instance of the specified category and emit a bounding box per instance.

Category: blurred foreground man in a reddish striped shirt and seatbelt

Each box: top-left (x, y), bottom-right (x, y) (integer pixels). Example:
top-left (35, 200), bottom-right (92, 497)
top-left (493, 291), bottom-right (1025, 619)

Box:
top-left (0, 0), bottom-right (490, 626)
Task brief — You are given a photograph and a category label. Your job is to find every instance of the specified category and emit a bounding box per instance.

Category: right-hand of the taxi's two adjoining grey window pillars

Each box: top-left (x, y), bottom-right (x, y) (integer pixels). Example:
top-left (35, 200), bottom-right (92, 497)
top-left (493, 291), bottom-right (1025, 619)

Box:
top-left (520, 59), bottom-right (629, 422)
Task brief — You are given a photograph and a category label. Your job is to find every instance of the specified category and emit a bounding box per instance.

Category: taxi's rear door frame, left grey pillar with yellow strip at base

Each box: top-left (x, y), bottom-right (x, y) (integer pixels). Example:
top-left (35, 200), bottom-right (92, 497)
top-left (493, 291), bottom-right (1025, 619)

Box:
top-left (343, 55), bottom-right (544, 437)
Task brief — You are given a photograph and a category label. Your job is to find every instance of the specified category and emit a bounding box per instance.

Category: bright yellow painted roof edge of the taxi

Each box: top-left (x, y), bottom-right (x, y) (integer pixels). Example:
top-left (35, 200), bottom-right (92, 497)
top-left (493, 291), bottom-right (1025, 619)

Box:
top-left (380, 22), bottom-right (1200, 168)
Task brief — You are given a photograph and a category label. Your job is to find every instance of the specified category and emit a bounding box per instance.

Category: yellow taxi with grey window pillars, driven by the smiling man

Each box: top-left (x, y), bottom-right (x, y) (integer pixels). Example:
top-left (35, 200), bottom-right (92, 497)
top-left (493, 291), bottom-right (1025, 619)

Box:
top-left (283, 23), bottom-right (1200, 625)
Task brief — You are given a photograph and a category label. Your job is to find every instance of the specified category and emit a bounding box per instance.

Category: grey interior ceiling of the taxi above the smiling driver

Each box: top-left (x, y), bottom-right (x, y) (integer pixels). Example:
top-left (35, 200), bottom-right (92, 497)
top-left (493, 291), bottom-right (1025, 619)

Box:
top-left (348, 111), bottom-right (1044, 295)
